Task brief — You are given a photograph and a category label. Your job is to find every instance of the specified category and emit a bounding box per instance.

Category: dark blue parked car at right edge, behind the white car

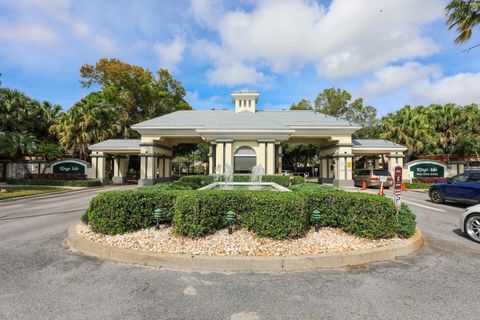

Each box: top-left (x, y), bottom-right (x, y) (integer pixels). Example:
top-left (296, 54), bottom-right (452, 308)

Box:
top-left (429, 171), bottom-right (480, 204)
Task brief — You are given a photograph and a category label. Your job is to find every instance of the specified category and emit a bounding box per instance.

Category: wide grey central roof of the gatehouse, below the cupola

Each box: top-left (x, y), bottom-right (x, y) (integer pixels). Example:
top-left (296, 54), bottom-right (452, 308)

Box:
top-left (132, 110), bottom-right (357, 129)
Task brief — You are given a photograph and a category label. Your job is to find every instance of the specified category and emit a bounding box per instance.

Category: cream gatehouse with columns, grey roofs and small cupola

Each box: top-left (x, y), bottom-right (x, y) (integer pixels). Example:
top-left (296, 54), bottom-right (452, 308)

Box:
top-left (89, 90), bottom-right (406, 186)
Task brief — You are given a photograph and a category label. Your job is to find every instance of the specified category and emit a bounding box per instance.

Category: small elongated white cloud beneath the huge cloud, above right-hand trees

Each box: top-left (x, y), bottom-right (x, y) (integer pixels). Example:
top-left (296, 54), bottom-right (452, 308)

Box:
top-left (361, 62), bottom-right (440, 97)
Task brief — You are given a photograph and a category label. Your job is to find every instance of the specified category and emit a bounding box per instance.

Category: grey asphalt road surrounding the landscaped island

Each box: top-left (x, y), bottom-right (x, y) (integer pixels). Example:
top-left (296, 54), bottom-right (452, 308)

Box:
top-left (0, 185), bottom-right (480, 319)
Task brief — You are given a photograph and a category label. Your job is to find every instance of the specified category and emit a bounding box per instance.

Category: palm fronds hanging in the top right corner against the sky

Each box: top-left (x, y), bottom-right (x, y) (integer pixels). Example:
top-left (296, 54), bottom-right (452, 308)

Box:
top-left (445, 0), bottom-right (480, 44)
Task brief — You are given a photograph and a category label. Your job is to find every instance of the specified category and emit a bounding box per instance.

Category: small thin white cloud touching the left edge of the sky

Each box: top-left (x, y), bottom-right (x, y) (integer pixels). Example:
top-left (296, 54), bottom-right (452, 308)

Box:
top-left (0, 24), bottom-right (59, 46)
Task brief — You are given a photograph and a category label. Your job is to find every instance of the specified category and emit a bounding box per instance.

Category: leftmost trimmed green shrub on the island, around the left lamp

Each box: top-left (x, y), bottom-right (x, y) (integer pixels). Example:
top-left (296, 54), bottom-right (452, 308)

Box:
top-left (84, 188), bottom-right (185, 234)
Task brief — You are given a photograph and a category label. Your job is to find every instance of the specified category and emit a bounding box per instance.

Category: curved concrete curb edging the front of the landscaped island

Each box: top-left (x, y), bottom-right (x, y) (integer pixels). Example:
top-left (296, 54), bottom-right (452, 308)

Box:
top-left (67, 224), bottom-right (424, 272)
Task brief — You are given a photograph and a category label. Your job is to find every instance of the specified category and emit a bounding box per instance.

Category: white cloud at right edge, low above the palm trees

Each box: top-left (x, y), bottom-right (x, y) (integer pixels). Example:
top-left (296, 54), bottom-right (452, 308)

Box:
top-left (412, 73), bottom-right (480, 105)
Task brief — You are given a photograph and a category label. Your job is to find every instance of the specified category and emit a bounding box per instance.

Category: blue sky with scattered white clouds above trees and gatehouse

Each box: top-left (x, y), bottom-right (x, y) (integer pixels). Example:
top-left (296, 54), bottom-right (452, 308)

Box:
top-left (0, 0), bottom-right (480, 115)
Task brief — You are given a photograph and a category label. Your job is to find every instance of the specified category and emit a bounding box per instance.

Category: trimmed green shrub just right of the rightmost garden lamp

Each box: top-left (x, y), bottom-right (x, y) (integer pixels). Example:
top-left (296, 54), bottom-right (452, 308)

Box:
top-left (308, 191), bottom-right (397, 239)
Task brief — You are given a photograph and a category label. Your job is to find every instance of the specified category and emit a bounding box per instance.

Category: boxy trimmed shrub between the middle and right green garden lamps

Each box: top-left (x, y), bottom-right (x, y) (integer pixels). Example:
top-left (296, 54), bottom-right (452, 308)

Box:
top-left (242, 192), bottom-right (310, 240)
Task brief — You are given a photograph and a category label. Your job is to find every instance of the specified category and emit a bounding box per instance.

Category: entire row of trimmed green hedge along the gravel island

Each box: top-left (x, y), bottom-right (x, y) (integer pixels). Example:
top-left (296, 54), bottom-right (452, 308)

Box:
top-left (84, 186), bottom-right (415, 239)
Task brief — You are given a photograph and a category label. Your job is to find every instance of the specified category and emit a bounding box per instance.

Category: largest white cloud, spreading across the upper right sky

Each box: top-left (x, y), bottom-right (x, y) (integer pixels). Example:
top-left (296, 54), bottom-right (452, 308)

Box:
top-left (191, 0), bottom-right (443, 84)
